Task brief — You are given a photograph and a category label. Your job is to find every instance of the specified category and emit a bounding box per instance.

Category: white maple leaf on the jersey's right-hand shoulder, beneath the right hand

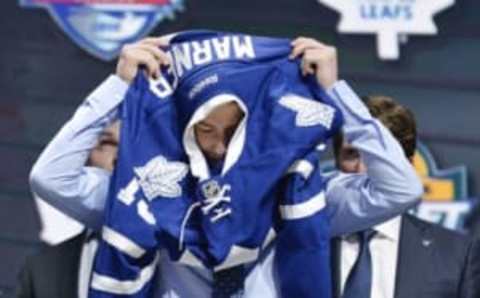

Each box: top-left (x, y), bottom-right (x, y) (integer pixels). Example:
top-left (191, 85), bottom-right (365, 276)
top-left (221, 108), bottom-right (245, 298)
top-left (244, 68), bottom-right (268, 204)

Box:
top-left (279, 94), bottom-right (335, 129)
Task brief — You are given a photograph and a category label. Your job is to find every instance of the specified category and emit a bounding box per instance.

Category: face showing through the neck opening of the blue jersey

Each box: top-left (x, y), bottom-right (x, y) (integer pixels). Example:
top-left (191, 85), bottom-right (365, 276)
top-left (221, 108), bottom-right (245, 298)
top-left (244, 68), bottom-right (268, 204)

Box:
top-left (194, 101), bottom-right (244, 163)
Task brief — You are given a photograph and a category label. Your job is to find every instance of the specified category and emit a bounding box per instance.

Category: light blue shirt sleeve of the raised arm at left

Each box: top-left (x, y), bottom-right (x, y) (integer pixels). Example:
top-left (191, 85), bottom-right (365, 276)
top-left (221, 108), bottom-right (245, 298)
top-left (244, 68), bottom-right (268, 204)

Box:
top-left (30, 76), bottom-right (127, 227)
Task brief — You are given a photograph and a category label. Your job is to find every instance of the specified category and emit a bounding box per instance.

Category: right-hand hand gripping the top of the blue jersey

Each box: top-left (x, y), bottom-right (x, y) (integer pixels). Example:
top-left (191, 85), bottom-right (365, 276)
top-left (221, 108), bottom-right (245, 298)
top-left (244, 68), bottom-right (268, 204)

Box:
top-left (290, 37), bottom-right (338, 89)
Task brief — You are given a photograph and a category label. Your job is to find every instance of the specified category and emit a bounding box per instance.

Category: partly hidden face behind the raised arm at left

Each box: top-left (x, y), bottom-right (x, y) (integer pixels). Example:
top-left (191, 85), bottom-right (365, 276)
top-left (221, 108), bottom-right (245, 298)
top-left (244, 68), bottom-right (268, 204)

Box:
top-left (87, 121), bottom-right (120, 171)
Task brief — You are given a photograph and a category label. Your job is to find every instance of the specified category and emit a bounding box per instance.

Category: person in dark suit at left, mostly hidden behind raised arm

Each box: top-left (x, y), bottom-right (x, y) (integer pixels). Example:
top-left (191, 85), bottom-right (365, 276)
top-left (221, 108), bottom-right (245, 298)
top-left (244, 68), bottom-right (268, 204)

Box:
top-left (16, 121), bottom-right (120, 298)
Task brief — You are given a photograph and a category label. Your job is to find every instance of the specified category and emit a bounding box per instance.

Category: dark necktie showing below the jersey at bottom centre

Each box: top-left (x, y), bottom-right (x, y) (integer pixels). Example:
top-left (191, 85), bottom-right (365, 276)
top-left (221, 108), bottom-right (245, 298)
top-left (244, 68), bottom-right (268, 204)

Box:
top-left (212, 265), bottom-right (245, 298)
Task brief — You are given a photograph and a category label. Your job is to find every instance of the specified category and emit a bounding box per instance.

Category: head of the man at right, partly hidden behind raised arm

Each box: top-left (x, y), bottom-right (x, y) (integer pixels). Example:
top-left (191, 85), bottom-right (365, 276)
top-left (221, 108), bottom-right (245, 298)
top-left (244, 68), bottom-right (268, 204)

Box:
top-left (333, 95), bottom-right (417, 173)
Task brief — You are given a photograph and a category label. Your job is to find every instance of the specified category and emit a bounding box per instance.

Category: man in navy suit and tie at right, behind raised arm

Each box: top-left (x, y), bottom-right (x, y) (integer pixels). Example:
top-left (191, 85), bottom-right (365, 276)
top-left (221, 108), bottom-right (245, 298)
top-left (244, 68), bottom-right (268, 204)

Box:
top-left (332, 96), bottom-right (480, 298)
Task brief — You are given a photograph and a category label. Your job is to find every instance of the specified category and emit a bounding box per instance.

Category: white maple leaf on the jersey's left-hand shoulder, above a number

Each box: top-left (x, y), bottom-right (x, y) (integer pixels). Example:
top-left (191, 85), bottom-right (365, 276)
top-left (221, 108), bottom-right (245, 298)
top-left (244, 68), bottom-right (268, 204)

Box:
top-left (134, 155), bottom-right (188, 201)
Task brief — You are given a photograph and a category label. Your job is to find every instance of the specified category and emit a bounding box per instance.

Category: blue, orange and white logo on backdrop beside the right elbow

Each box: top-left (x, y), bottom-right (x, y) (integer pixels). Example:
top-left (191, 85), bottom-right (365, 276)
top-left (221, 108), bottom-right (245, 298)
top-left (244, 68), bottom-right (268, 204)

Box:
top-left (413, 143), bottom-right (473, 229)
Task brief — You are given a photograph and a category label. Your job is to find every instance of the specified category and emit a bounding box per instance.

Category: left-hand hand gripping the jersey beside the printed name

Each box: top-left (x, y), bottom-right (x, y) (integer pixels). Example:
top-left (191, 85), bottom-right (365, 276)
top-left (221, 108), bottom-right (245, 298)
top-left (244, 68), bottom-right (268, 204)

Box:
top-left (116, 37), bottom-right (170, 84)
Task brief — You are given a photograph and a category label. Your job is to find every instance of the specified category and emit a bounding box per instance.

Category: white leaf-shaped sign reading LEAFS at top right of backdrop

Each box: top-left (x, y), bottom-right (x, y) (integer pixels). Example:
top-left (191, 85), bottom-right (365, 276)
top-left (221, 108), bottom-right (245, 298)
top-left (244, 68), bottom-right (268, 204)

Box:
top-left (318, 0), bottom-right (455, 60)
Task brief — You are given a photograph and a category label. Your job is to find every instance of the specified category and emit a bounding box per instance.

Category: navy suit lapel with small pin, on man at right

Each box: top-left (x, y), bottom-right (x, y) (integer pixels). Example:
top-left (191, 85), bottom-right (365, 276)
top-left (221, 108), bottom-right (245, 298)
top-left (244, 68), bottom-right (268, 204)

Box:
top-left (394, 215), bottom-right (435, 298)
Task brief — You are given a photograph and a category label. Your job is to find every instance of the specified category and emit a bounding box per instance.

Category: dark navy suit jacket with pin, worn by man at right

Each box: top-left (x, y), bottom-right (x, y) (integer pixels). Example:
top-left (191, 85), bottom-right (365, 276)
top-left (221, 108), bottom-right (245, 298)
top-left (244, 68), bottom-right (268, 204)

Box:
top-left (332, 215), bottom-right (480, 298)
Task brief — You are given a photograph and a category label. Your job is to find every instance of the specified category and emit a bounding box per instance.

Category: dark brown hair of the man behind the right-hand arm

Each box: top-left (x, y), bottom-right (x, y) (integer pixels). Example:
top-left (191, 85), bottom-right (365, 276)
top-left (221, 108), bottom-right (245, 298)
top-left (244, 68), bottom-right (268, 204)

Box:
top-left (333, 95), bottom-right (417, 163)
